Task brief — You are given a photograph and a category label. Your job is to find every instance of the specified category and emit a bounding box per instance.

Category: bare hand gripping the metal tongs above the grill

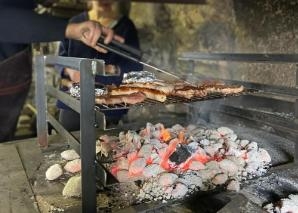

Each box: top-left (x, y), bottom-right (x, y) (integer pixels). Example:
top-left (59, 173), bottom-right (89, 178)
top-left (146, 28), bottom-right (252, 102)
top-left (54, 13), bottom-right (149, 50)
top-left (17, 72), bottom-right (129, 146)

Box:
top-left (65, 21), bottom-right (124, 53)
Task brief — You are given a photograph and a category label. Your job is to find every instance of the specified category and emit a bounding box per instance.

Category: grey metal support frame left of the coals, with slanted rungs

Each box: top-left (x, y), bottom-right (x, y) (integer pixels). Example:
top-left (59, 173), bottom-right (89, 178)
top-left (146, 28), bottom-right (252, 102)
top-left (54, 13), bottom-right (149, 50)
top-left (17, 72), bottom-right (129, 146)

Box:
top-left (34, 56), bottom-right (112, 213)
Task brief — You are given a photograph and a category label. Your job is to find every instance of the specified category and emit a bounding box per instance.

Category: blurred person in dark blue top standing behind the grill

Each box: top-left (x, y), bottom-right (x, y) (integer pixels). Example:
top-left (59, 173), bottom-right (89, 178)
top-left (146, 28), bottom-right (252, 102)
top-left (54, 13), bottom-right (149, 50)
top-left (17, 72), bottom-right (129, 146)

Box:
top-left (57, 0), bottom-right (143, 131)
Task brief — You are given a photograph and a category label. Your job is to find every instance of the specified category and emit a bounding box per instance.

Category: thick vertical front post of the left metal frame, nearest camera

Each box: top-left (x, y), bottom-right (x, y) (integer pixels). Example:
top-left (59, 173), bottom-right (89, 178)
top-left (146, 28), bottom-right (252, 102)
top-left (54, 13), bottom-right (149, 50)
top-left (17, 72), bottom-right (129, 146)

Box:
top-left (80, 59), bottom-right (96, 213)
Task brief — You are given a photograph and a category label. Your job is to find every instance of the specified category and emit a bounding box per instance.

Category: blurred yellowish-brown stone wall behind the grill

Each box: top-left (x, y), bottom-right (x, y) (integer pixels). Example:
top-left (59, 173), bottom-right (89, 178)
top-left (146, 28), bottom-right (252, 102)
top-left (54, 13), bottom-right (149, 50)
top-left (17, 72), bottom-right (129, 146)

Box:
top-left (130, 0), bottom-right (298, 86)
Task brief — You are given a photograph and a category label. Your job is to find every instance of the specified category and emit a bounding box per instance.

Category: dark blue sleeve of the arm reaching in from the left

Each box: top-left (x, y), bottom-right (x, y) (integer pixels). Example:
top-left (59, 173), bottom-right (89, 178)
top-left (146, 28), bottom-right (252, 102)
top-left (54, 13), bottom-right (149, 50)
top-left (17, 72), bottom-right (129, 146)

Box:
top-left (0, 8), bottom-right (68, 43)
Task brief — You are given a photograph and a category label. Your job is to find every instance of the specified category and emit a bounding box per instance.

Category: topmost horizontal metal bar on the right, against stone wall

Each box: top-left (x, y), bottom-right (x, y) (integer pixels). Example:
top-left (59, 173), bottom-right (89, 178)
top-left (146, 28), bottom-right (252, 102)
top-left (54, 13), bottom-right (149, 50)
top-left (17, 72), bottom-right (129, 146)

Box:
top-left (178, 52), bottom-right (298, 63)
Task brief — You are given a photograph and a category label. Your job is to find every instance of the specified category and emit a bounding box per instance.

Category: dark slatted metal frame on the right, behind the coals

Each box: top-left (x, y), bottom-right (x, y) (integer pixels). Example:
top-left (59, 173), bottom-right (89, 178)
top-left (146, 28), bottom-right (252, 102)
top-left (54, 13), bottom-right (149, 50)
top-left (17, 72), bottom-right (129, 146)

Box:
top-left (178, 52), bottom-right (298, 163)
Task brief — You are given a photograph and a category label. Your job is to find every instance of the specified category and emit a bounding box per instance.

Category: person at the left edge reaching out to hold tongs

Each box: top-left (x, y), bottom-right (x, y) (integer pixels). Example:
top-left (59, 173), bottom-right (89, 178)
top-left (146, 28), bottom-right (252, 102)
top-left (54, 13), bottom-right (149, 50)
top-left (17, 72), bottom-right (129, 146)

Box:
top-left (0, 0), bottom-right (123, 142)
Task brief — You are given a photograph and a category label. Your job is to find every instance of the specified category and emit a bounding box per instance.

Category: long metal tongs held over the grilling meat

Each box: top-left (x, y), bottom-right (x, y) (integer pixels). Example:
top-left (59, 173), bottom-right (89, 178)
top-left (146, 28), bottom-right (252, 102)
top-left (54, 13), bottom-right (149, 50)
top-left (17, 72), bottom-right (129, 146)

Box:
top-left (97, 36), bottom-right (192, 84)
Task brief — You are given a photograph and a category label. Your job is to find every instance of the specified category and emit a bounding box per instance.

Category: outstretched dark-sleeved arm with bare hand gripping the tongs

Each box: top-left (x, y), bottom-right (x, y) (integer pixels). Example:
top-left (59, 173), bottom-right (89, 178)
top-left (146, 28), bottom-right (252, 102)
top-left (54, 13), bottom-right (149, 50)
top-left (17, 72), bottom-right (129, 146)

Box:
top-left (0, 6), bottom-right (124, 52)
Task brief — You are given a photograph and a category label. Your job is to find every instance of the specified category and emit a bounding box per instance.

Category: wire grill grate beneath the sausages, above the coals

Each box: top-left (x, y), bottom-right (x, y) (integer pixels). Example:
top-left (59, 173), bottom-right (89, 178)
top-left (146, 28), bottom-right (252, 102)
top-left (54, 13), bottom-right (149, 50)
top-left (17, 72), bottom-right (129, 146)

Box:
top-left (95, 89), bottom-right (258, 111)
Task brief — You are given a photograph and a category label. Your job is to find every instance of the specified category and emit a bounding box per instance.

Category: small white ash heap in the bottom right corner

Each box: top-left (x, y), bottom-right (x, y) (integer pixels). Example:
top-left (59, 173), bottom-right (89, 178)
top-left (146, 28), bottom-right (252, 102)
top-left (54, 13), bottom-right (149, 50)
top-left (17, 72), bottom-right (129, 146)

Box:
top-left (263, 194), bottom-right (298, 213)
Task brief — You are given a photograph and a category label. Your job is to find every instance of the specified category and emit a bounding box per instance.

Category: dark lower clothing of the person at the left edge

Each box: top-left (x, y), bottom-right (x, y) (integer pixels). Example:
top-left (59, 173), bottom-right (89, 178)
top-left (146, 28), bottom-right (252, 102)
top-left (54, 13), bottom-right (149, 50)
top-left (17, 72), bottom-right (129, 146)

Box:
top-left (0, 50), bottom-right (32, 142)
